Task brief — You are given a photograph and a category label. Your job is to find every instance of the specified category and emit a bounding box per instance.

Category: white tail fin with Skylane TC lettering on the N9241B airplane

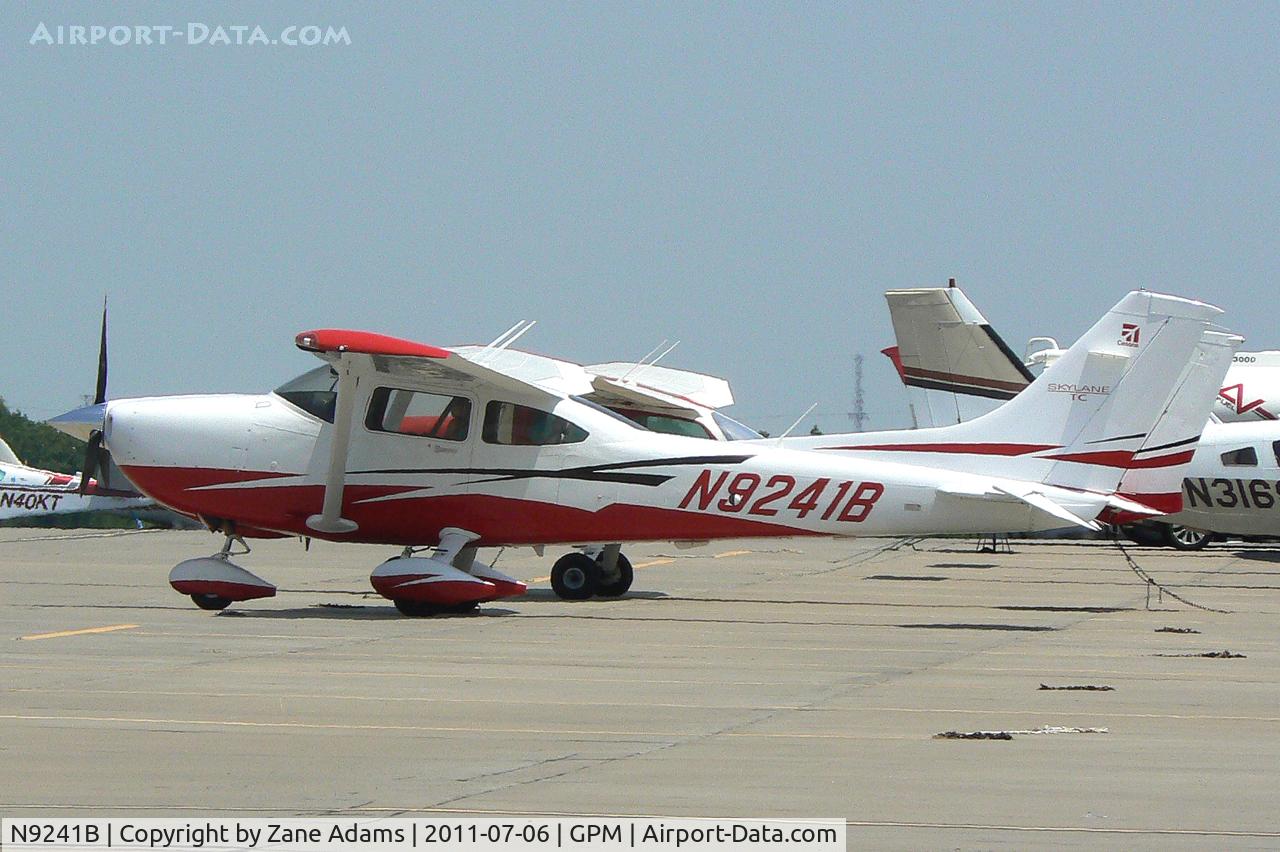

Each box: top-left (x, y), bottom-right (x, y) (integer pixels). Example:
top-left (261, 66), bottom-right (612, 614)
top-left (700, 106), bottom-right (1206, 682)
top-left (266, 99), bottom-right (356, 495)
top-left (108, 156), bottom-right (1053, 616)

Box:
top-left (814, 292), bottom-right (1221, 493)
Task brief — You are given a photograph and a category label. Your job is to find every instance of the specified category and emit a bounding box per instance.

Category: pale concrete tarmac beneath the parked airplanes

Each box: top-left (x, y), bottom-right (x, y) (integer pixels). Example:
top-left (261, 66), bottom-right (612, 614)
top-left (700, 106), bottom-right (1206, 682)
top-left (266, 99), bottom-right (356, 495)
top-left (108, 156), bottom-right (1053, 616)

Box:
top-left (0, 530), bottom-right (1280, 849)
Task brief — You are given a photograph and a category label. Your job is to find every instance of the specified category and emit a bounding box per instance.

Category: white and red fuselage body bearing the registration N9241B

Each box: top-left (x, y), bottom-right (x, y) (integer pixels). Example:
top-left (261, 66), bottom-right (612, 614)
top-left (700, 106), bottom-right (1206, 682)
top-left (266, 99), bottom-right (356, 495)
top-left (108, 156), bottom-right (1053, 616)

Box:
top-left (94, 385), bottom-right (1106, 545)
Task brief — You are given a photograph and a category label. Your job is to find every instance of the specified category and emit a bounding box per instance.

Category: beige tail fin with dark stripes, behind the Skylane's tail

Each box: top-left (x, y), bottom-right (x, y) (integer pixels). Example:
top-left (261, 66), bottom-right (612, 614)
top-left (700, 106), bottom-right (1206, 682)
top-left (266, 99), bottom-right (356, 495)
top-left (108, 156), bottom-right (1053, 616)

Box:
top-left (884, 287), bottom-right (1036, 426)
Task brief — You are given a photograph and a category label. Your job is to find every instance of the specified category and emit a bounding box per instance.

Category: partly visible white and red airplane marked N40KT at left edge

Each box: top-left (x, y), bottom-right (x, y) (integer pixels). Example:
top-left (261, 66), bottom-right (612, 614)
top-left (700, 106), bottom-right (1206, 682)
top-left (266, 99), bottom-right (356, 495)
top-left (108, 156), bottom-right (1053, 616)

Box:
top-left (0, 439), bottom-right (154, 521)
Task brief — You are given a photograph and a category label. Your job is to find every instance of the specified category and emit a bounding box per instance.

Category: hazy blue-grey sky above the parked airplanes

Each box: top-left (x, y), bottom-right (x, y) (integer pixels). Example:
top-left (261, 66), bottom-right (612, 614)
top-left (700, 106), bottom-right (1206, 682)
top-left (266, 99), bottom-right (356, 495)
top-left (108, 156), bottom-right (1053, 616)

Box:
top-left (0, 1), bottom-right (1280, 432)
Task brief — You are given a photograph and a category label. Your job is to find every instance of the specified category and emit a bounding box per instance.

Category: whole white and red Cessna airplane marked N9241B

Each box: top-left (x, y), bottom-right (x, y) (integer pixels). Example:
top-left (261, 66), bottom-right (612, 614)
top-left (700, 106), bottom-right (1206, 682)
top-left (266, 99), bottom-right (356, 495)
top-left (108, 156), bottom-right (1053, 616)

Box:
top-left (51, 293), bottom-right (1221, 614)
